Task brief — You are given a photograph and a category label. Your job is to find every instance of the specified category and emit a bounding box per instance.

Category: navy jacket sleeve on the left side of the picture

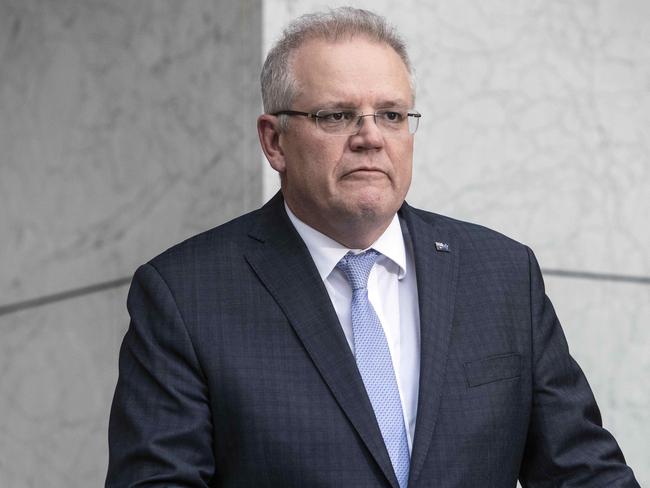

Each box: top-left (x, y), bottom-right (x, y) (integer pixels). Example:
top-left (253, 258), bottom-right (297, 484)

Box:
top-left (106, 264), bottom-right (214, 488)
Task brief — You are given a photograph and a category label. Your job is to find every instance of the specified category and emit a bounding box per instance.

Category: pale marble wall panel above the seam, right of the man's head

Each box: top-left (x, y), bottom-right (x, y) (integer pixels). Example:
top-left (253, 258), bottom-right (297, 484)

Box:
top-left (264, 0), bottom-right (650, 276)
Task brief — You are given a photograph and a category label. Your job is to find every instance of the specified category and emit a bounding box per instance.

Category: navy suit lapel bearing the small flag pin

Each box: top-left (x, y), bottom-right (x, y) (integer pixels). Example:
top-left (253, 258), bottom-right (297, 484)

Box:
top-left (400, 203), bottom-right (460, 480)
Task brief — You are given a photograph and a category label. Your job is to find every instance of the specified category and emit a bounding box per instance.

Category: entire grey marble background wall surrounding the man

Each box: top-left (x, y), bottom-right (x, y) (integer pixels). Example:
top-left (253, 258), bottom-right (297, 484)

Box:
top-left (0, 0), bottom-right (650, 487)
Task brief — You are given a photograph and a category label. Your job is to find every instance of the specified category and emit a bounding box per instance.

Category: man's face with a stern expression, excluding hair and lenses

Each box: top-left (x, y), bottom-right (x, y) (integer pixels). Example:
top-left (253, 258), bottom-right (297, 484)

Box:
top-left (276, 37), bottom-right (413, 242)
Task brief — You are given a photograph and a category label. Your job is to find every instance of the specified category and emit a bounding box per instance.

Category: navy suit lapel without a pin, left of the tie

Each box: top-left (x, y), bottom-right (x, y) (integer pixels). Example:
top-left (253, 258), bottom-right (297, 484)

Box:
top-left (245, 194), bottom-right (398, 487)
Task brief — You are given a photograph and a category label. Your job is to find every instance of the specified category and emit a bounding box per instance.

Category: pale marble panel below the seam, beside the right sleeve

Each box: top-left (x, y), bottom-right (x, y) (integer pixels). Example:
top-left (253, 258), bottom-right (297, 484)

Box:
top-left (545, 277), bottom-right (650, 486)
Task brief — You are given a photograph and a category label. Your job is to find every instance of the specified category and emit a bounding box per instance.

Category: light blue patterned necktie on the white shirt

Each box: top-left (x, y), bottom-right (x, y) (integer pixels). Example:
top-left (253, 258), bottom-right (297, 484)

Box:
top-left (336, 249), bottom-right (410, 488)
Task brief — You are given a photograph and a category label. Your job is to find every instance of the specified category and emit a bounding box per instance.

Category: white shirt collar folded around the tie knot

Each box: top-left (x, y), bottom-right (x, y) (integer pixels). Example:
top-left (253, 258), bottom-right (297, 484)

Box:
top-left (284, 202), bottom-right (406, 281)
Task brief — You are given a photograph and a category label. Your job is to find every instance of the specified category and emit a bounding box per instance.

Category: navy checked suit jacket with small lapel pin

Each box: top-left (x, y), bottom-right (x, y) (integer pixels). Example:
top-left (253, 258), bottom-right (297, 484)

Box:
top-left (106, 195), bottom-right (638, 488)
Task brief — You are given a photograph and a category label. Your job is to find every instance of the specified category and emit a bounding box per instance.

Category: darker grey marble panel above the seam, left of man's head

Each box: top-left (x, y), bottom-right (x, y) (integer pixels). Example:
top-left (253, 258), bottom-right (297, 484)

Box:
top-left (0, 0), bottom-right (261, 304)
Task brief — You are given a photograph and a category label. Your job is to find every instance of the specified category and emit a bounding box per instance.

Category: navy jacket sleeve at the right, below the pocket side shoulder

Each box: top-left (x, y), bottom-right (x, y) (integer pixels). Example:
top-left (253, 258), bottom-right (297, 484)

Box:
top-left (520, 249), bottom-right (639, 488)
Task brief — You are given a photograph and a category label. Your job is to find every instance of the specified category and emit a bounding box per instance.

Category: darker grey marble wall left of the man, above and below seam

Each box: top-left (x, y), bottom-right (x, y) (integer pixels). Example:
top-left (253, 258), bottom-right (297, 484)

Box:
top-left (0, 0), bottom-right (262, 488)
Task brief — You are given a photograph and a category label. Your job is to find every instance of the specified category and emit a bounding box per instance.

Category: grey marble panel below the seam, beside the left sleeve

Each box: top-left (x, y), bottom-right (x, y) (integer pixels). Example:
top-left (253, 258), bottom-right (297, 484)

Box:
top-left (0, 286), bottom-right (128, 488)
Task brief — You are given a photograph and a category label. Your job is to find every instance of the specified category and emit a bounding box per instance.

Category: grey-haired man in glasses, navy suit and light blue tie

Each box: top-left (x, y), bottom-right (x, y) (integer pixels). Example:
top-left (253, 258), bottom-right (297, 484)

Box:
top-left (106, 8), bottom-right (638, 488)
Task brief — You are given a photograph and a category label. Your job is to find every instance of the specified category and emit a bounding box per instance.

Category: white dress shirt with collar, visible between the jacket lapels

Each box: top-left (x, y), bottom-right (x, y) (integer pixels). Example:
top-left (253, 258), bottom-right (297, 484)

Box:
top-left (284, 202), bottom-right (420, 451)
